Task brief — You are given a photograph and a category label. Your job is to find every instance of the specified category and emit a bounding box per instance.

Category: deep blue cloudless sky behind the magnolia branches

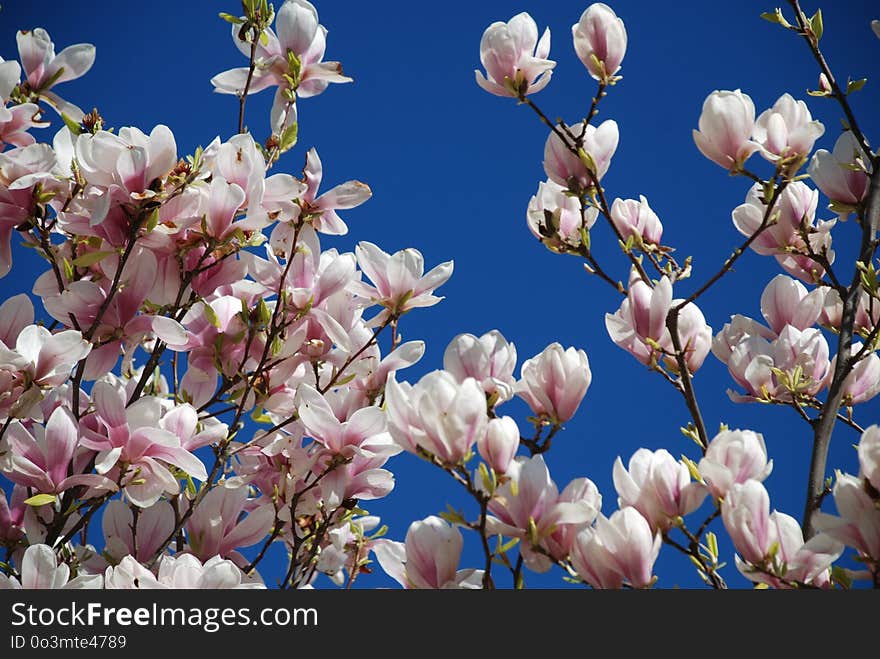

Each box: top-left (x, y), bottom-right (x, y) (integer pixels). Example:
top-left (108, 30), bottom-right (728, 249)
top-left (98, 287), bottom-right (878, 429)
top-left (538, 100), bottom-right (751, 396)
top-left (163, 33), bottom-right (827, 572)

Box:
top-left (0, 0), bottom-right (880, 588)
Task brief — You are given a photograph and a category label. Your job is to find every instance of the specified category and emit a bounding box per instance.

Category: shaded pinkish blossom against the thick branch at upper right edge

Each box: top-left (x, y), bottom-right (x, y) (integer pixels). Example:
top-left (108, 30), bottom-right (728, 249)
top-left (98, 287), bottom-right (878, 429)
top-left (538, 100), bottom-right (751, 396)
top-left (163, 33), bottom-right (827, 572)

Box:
top-left (807, 131), bottom-right (871, 206)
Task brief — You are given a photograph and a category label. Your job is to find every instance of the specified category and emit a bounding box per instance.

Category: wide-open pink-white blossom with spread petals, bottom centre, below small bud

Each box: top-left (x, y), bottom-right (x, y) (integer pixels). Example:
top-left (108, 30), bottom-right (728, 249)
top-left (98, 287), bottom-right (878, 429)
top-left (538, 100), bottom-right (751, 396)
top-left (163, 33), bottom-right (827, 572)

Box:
top-left (487, 455), bottom-right (602, 572)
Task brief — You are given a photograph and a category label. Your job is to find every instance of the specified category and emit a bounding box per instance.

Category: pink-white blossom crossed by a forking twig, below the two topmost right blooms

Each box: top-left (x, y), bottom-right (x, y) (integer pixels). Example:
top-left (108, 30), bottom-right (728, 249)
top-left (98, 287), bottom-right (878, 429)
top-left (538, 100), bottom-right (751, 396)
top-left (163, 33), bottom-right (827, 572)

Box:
top-left (544, 119), bottom-right (620, 191)
